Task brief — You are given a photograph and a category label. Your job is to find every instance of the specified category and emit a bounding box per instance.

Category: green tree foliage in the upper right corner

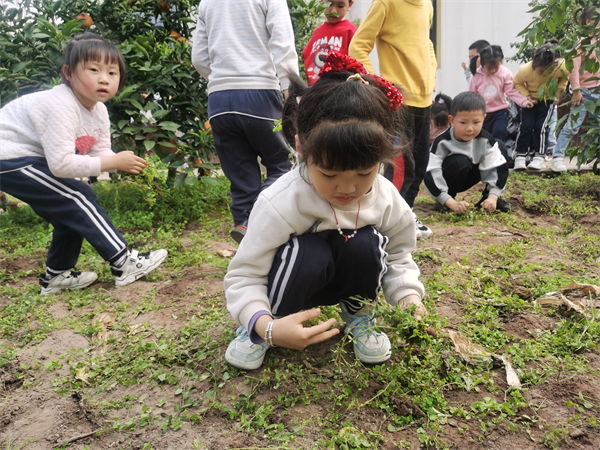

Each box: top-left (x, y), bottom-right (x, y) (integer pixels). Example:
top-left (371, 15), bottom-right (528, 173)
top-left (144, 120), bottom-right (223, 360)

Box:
top-left (512, 0), bottom-right (600, 173)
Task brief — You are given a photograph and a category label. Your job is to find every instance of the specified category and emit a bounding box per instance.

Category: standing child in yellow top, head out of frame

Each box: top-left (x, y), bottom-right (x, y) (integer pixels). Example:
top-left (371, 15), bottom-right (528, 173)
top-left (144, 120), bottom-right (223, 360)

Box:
top-left (348, 0), bottom-right (437, 239)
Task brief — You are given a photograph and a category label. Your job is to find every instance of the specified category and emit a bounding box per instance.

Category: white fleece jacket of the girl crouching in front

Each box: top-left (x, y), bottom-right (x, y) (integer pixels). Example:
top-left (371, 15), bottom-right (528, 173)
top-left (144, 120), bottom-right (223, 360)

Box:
top-left (224, 166), bottom-right (425, 329)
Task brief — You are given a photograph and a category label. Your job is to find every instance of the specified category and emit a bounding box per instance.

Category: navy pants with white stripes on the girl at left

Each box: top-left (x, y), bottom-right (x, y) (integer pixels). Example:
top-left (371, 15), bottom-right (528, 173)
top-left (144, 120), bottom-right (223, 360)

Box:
top-left (0, 157), bottom-right (127, 271)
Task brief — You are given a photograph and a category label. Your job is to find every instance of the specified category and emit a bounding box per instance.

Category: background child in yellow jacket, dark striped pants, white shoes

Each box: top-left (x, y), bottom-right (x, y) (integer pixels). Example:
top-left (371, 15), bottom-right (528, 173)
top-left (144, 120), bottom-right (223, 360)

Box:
top-left (514, 42), bottom-right (567, 170)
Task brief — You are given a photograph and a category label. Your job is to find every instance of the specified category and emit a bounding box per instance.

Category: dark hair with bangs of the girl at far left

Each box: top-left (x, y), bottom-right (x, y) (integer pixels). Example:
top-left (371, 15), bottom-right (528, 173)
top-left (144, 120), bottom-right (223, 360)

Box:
top-left (61, 33), bottom-right (127, 92)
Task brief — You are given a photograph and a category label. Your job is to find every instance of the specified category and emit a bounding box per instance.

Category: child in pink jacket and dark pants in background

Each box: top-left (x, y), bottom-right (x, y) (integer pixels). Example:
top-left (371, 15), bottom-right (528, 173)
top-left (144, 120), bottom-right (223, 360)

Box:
top-left (469, 45), bottom-right (533, 142)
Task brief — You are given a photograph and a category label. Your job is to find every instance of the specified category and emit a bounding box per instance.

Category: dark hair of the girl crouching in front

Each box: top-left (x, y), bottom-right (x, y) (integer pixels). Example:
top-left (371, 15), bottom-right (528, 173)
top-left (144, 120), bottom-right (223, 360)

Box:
top-left (282, 72), bottom-right (407, 171)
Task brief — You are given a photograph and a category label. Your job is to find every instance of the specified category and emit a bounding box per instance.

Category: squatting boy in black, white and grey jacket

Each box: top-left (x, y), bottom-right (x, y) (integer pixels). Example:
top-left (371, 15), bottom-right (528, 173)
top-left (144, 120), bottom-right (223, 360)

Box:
top-left (425, 92), bottom-right (510, 214)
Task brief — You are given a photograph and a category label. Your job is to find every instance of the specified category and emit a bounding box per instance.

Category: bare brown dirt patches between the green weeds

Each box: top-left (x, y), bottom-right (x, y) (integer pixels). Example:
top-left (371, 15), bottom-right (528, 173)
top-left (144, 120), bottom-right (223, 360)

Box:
top-left (0, 180), bottom-right (600, 450)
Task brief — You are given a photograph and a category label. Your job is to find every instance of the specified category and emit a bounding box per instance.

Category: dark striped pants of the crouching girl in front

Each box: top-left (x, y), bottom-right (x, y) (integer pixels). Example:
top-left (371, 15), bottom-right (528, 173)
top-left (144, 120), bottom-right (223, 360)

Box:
top-left (267, 226), bottom-right (388, 317)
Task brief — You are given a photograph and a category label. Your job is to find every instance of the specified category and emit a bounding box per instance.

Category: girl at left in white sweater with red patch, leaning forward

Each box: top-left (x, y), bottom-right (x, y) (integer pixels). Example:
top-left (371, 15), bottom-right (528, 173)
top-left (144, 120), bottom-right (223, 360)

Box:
top-left (0, 33), bottom-right (167, 294)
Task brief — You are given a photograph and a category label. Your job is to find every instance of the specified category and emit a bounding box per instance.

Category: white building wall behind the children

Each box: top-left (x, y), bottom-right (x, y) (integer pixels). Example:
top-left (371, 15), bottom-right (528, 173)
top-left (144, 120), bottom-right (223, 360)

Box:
top-left (346, 0), bottom-right (532, 97)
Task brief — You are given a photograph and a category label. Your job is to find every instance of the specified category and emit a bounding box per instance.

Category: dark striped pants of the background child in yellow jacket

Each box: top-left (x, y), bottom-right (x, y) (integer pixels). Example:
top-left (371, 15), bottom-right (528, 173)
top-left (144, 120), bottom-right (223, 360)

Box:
top-left (516, 100), bottom-right (554, 156)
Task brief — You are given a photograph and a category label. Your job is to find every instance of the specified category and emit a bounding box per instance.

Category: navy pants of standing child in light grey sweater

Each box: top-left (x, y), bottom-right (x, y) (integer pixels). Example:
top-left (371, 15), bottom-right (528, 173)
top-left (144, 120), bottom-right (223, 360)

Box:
top-left (208, 90), bottom-right (292, 225)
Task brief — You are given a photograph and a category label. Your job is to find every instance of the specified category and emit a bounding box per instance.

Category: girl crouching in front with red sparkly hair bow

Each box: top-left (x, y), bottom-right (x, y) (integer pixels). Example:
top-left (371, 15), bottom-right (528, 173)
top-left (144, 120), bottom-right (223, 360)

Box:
top-left (224, 52), bottom-right (425, 370)
